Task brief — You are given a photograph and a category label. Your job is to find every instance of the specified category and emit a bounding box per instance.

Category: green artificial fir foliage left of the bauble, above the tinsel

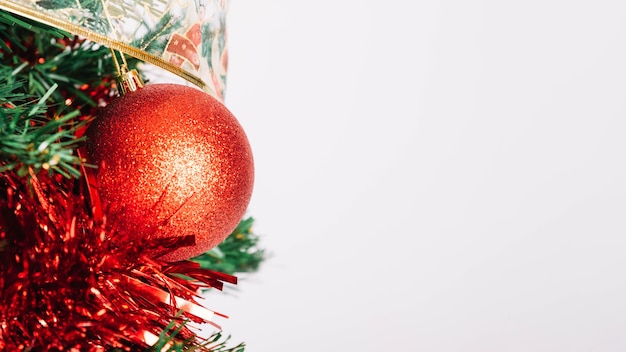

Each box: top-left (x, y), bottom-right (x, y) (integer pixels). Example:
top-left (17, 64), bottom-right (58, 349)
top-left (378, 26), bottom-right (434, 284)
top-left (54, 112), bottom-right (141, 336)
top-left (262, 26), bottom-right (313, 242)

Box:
top-left (0, 11), bottom-right (130, 177)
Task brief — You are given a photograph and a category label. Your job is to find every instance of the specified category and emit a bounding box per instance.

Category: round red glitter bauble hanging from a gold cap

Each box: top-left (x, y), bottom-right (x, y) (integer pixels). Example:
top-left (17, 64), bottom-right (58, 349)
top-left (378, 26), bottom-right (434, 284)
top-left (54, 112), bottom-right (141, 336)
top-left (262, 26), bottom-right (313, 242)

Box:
top-left (86, 84), bottom-right (254, 261)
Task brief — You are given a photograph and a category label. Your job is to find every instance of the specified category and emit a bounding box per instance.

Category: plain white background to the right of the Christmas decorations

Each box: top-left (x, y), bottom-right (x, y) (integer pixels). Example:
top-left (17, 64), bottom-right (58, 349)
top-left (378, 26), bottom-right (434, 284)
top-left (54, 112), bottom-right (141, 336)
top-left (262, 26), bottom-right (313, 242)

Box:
top-left (208, 0), bottom-right (626, 352)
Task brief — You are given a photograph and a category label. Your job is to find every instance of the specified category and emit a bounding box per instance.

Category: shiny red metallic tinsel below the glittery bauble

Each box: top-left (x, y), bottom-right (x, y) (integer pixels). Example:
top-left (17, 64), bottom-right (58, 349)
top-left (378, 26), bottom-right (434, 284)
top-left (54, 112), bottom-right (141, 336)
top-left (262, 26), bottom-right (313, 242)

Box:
top-left (0, 173), bottom-right (236, 351)
